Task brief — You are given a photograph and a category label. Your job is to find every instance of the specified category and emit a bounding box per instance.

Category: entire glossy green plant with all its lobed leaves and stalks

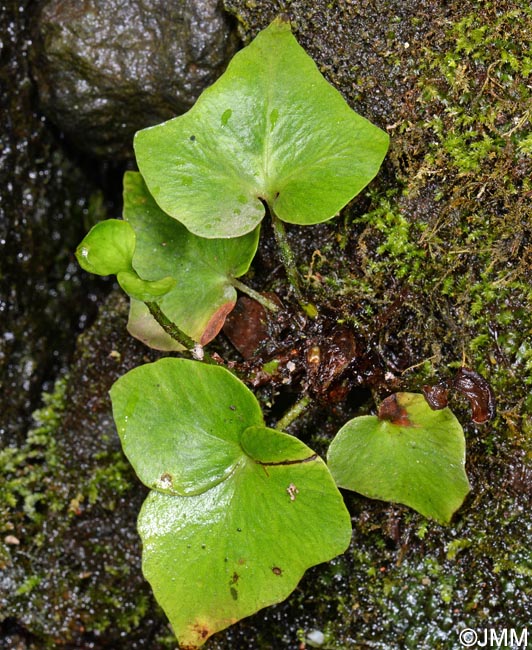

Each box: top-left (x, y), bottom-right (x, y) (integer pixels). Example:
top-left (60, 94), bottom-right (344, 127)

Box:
top-left (77, 20), bottom-right (490, 648)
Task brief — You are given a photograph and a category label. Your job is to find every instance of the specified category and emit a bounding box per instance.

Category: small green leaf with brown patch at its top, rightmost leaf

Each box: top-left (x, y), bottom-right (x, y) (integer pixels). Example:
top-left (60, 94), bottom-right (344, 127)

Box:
top-left (328, 393), bottom-right (469, 523)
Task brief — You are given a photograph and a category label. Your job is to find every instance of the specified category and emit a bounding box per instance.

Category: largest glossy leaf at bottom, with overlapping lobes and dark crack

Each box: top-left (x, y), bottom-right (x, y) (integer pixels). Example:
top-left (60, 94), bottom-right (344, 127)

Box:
top-left (111, 359), bottom-right (351, 648)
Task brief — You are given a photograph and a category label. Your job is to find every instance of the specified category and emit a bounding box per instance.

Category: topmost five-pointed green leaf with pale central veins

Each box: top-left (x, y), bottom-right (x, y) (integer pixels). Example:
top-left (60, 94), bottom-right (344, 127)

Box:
top-left (134, 20), bottom-right (388, 238)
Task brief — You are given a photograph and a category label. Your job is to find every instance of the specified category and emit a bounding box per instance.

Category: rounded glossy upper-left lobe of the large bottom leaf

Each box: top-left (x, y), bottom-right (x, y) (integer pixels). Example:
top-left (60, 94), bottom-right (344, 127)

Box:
top-left (110, 359), bottom-right (263, 495)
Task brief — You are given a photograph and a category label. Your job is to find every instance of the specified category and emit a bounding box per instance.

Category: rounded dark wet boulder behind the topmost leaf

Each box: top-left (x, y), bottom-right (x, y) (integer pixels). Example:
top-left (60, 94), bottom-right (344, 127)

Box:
top-left (29, 0), bottom-right (237, 159)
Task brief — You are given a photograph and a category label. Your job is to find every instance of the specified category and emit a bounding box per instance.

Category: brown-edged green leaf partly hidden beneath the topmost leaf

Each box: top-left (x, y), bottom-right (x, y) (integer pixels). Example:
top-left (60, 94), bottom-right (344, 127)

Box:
top-left (122, 172), bottom-right (259, 349)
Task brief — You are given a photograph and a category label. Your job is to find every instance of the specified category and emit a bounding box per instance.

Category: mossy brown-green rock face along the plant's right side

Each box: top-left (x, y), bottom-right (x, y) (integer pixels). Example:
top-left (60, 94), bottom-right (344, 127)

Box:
top-left (213, 0), bottom-right (532, 650)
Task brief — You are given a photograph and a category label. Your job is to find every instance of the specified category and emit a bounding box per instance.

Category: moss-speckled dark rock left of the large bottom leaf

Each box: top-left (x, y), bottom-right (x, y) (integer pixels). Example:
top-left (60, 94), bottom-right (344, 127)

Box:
top-left (0, 293), bottom-right (165, 650)
